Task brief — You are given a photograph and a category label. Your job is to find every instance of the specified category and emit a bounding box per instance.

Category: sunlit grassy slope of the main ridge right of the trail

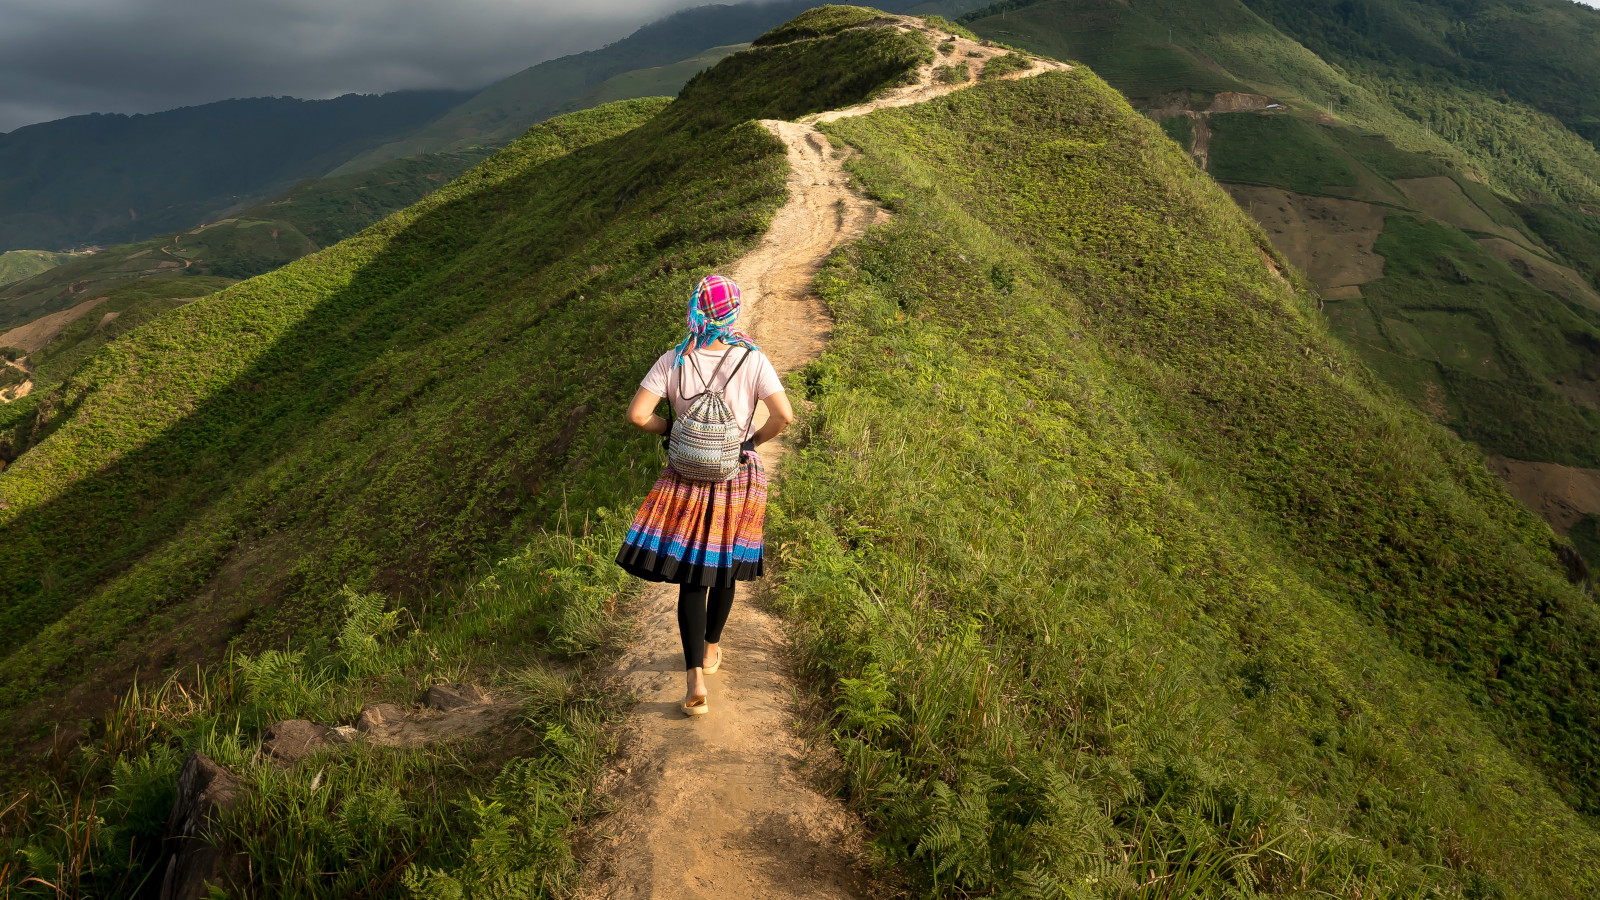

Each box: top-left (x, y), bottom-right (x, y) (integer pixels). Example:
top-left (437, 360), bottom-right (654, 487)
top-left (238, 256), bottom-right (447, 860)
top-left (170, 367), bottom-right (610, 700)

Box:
top-left (774, 70), bottom-right (1600, 897)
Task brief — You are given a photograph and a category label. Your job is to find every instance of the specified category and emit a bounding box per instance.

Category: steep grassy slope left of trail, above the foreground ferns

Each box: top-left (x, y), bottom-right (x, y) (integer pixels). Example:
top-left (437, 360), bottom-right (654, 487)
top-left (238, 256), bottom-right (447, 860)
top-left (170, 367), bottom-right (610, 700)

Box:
top-left (0, 14), bottom-right (931, 755)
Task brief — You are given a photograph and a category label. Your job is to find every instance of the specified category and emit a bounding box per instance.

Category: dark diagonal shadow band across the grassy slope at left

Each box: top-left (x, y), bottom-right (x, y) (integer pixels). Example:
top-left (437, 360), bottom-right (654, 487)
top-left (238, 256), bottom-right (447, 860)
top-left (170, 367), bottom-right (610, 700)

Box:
top-left (0, 126), bottom-right (649, 688)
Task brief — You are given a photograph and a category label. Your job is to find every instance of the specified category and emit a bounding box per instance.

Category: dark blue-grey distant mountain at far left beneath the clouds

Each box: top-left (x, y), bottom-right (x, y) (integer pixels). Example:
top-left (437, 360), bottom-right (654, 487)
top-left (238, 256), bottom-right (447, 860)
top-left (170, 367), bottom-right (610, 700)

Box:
top-left (0, 91), bottom-right (467, 250)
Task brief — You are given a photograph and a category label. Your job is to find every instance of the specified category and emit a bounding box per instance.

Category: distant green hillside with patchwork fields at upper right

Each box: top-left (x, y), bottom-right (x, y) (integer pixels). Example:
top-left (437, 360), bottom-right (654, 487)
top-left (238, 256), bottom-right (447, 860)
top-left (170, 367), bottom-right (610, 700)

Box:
top-left (965, 0), bottom-right (1600, 565)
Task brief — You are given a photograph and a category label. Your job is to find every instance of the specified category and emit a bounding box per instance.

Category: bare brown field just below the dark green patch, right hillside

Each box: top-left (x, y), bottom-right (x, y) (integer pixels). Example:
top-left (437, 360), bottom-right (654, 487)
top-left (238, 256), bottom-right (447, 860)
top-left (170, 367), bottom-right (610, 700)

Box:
top-left (1222, 184), bottom-right (1384, 299)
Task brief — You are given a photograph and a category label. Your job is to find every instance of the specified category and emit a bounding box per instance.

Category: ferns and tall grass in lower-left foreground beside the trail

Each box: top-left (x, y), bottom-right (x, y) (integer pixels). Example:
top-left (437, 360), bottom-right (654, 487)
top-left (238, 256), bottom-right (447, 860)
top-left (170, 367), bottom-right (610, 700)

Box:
top-left (0, 519), bottom-right (626, 898)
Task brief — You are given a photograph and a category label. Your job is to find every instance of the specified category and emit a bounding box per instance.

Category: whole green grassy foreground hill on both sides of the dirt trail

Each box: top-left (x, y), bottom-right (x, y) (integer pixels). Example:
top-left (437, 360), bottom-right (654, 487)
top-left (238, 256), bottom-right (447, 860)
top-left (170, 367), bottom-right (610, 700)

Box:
top-left (0, 8), bottom-right (1600, 900)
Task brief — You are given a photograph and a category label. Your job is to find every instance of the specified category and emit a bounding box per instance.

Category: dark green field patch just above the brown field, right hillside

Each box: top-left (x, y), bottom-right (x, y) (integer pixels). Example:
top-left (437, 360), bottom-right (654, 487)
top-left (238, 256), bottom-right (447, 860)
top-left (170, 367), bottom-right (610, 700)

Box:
top-left (1210, 112), bottom-right (1357, 194)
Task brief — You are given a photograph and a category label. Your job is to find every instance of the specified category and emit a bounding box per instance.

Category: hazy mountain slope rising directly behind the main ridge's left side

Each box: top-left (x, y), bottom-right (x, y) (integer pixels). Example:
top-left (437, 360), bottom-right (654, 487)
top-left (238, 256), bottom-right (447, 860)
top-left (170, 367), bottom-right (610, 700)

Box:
top-left (324, 0), bottom-right (909, 175)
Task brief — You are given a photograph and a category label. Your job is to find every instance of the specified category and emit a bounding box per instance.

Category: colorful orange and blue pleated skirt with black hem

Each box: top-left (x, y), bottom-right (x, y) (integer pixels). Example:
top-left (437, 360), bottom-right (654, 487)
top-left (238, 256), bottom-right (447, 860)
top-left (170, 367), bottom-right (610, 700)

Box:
top-left (616, 453), bottom-right (766, 588)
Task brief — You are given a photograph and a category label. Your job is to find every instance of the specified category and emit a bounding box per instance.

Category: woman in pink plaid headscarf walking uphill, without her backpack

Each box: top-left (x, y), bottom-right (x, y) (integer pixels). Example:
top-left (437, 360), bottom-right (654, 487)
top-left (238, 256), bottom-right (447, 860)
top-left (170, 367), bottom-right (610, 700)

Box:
top-left (616, 275), bottom-right (795, 716)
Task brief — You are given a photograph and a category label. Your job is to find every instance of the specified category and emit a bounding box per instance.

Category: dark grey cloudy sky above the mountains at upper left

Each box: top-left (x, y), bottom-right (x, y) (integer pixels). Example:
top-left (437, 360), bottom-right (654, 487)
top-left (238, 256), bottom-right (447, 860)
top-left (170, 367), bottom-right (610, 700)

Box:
top-left (0, 0), bottom-right (704, 133)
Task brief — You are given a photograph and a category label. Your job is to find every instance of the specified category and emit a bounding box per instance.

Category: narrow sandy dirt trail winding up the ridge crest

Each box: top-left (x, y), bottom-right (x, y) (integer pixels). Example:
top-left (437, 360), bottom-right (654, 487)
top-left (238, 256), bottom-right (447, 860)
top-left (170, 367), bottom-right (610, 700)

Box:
top-left (581, 16), bottom-right (1066, 900)
